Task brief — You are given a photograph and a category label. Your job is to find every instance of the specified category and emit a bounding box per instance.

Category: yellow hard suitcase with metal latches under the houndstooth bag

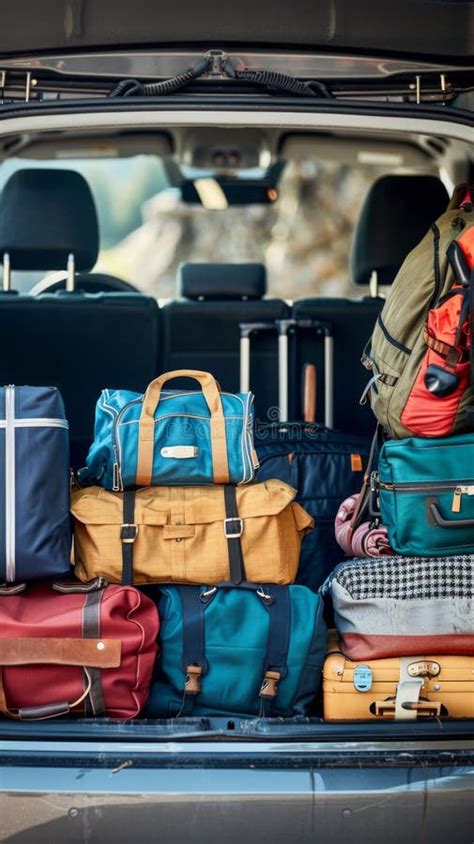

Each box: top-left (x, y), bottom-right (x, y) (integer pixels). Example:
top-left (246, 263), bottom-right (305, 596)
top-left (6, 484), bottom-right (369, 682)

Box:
top-left (323, 636), bottom-right (474, 721)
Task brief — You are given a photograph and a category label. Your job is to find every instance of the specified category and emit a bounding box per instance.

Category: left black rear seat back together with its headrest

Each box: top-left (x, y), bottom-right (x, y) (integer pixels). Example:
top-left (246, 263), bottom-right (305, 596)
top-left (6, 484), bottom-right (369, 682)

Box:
top-left (0, 169), bottom-right (161, 467)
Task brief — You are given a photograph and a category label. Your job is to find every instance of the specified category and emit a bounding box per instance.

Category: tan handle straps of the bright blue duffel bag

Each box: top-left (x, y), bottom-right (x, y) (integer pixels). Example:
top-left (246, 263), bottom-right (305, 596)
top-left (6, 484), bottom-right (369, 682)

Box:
top-left (136, 369), bottom-right (229, 486)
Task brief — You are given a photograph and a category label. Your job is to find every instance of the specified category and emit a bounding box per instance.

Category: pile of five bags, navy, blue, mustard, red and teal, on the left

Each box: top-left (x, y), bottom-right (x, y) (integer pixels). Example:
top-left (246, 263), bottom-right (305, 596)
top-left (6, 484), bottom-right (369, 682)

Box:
top-left (0, 370), bottom-right (327, 719)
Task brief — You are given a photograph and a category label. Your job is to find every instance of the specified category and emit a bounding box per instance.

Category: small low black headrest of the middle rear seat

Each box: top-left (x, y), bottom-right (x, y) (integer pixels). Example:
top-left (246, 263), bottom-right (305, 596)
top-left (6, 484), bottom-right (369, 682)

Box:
top-left (179, 263), bottom-right (267, 300)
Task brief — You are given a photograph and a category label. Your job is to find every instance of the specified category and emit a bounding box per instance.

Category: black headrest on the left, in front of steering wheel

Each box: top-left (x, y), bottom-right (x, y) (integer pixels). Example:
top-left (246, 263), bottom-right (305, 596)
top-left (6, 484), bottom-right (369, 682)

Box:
top-left (0, 168), bottom-right (99, 271)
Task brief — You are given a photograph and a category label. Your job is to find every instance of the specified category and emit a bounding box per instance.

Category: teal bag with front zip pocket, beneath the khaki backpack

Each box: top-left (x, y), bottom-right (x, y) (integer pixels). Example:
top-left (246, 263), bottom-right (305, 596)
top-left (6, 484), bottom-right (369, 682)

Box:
top-left (378, 433), bottom-right (474, 557)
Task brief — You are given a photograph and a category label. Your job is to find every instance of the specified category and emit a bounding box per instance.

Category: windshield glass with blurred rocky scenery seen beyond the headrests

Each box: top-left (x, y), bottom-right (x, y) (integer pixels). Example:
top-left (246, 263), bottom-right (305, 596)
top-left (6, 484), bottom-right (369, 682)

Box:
top-left (0, 156), bottom-right (386, 300)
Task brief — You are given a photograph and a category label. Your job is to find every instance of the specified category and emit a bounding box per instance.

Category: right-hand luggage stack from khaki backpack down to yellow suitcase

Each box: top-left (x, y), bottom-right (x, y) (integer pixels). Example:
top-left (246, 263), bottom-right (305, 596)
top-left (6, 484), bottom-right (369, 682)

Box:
top-left (321, 183), bottom-right (474, 720)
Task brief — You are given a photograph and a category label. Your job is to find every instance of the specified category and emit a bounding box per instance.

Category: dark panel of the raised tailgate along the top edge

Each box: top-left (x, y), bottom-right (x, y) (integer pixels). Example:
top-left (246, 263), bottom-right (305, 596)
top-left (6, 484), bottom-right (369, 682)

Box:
top-left (0, 0), bottom-right (474, 59)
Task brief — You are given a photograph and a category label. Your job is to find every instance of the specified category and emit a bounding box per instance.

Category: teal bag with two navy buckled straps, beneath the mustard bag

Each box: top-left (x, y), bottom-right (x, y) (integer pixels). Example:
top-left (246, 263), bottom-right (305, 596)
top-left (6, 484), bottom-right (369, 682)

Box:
top-left (147, 584), bottom-right (327, 718)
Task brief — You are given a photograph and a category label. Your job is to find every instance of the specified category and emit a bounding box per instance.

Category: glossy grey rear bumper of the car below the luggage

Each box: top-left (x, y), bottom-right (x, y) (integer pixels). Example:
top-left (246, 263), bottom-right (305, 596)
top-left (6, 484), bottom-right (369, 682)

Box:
top-left (0, 740), bottom-right (474, 844)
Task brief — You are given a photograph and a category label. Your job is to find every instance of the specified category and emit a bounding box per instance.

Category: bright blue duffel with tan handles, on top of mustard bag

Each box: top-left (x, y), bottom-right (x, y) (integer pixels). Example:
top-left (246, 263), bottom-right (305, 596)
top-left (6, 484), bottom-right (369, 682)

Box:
top-left (79, 369), bottom-right (257, 490)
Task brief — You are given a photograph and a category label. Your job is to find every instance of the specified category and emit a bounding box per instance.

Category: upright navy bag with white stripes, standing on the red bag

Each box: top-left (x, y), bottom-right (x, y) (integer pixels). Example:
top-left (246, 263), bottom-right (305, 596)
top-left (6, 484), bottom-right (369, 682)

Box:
top-left (0, 386), bottom-right (71, 583)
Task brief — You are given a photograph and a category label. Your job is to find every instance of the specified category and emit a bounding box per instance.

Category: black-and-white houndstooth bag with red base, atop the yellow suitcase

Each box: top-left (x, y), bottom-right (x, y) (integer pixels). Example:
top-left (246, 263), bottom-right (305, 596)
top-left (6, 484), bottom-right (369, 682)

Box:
top-left (322, 555), bottom-right (474, 661)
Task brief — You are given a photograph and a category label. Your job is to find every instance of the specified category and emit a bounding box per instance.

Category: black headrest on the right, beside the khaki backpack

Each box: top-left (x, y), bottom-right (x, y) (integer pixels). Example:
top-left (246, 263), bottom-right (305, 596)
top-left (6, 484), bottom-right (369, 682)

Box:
top-left (350, 176), bottom-right (449, 284)
